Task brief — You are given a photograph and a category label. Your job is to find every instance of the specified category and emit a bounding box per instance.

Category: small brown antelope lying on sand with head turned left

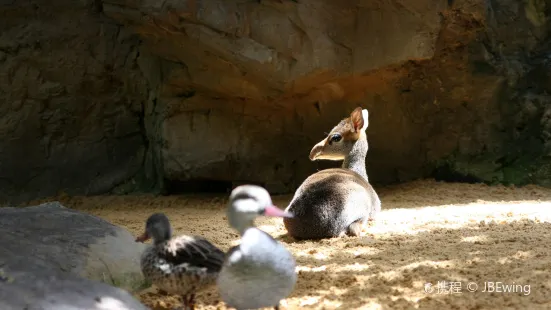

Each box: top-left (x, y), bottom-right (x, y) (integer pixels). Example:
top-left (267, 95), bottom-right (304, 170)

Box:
top-left (283, 107), bottom-right (381, 239)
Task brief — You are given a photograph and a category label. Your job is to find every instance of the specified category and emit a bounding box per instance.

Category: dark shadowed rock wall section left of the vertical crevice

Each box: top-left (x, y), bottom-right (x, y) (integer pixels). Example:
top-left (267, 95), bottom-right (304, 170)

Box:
top-left (0, 0), bottom-right (149, 202)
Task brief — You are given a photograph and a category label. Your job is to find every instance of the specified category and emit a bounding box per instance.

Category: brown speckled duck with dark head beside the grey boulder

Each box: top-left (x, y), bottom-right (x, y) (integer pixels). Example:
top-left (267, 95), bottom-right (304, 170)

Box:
top-left (136, 213), bottom-right (224, 309)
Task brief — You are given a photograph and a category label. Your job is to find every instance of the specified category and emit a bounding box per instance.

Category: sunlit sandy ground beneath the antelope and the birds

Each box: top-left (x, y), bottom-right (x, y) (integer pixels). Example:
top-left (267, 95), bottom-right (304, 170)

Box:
top-left (41, 180), bottom-right (551, 310)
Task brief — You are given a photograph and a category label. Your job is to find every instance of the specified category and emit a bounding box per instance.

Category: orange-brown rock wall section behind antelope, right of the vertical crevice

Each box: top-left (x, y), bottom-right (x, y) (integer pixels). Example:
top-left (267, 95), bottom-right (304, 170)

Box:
top-left (102, 0), bottom-right (551, 192)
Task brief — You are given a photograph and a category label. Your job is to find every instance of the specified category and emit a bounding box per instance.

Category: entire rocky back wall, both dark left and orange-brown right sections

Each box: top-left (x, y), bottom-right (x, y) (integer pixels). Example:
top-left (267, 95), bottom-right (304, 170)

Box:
top-left (0, 0), bottom-right (551, 200)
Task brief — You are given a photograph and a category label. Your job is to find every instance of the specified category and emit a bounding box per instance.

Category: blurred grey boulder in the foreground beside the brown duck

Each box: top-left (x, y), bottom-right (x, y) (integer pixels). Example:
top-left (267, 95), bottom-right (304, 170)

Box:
top-left (0, 202), bottom-right (145, 290)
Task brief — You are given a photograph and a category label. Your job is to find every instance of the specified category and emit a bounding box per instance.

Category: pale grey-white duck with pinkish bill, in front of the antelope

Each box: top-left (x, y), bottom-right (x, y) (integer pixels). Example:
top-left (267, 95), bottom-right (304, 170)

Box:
top-left (217, 185), bottom-right (297, 310)
